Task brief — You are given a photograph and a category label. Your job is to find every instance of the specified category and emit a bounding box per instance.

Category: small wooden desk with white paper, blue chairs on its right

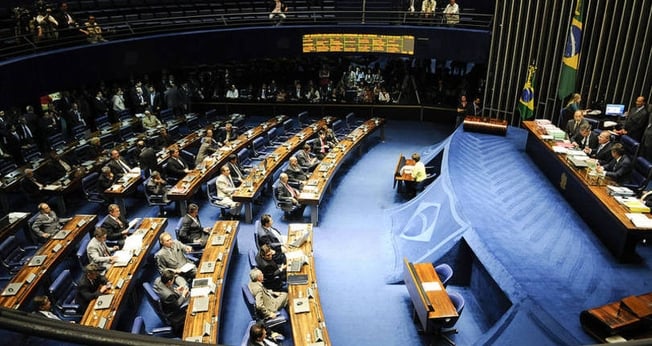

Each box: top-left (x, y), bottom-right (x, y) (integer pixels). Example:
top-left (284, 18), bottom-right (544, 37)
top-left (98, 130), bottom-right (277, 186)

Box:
top-left (403, 258), bottom-right (458, 333)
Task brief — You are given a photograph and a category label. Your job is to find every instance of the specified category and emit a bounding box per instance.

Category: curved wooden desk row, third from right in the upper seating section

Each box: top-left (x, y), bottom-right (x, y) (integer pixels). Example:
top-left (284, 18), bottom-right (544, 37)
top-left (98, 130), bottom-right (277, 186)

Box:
top-left (167, 115), bottom-right (287, 215)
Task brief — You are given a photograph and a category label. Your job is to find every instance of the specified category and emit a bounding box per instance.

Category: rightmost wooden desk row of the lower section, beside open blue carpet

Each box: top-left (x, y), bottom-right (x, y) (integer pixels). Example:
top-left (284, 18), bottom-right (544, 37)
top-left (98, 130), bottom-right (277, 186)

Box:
top-left (288, 223), bottom-right (333, 346)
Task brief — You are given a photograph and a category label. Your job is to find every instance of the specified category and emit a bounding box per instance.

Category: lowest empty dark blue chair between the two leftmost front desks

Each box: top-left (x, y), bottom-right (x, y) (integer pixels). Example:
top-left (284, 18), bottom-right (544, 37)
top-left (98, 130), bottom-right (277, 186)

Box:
top-left (48, 269), bottom-right (83, 321)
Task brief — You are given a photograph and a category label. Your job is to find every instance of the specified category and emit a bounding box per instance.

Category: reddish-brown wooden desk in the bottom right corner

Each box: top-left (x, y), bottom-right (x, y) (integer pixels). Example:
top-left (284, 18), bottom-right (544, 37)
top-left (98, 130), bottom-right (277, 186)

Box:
top-left (580, 292), bottom-right (652, 343)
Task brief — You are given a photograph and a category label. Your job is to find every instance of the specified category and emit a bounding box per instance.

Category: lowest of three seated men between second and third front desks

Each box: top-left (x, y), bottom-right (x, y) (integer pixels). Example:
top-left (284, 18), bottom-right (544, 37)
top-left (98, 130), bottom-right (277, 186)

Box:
top-left (154, 270), bottom-right (190, 336)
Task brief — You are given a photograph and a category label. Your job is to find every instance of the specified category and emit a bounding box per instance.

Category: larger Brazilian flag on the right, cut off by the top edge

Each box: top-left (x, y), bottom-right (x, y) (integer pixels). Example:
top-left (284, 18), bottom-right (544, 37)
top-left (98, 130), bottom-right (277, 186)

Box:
top-left (557, 0), bottom-right (584, 100)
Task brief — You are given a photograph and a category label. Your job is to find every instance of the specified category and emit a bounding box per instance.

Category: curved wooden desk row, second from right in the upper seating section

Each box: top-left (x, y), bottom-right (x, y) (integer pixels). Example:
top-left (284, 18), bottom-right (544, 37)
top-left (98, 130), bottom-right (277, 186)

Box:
top-left (231, 117), bottom-right (333, 223)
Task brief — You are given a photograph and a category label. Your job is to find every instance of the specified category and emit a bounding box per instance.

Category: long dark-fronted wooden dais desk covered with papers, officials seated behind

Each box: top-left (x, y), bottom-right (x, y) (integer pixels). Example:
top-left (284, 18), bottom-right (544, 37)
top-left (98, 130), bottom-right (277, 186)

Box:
top-left (523, 121), bottom-right (652, 261)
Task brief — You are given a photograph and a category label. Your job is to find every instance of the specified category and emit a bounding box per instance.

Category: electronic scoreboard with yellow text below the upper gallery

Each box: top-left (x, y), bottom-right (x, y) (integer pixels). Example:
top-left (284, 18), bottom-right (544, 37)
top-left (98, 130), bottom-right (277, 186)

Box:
top-left (303, 34), bottom-right (414, 55)
